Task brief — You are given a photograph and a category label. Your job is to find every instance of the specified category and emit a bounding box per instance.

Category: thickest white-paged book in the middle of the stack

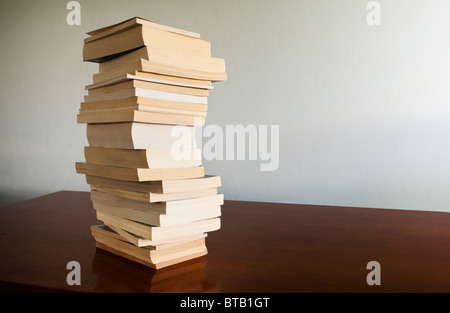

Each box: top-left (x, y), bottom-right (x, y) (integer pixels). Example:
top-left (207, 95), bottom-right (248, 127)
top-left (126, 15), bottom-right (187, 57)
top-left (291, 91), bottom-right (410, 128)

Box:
top-left (86, 122), bottom-right (197, 150)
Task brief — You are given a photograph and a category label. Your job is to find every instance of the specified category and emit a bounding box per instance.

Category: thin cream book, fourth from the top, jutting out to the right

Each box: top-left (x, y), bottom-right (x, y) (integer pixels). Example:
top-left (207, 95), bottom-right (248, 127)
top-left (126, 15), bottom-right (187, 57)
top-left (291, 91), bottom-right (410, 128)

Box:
top-left (93, 59), bottom-right (227, 83)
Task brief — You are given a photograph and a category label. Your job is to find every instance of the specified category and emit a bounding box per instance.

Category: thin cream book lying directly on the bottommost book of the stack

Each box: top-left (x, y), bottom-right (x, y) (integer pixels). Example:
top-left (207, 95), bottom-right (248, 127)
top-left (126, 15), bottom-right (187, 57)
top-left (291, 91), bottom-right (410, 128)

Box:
top-left (91, 225), bottom-right (207, 250)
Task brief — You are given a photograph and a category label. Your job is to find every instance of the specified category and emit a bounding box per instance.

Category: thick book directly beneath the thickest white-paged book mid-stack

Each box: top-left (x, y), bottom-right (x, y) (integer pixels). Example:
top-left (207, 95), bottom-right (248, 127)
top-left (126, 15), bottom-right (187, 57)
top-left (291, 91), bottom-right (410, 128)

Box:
top-left (84, 147), bottom-right (202, 169)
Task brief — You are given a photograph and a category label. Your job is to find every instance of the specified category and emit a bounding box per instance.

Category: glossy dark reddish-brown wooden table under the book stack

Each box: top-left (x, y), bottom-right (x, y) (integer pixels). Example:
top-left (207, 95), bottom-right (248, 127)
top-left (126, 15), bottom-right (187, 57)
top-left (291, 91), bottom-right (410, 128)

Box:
top-left (0, 191), bottom-right (450, 292)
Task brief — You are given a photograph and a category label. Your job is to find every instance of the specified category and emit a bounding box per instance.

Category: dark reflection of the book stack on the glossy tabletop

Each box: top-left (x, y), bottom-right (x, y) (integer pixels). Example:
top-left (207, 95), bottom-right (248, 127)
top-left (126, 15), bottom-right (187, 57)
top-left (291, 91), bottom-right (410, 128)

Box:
top-left (92, 244), bottom-right (220, 293)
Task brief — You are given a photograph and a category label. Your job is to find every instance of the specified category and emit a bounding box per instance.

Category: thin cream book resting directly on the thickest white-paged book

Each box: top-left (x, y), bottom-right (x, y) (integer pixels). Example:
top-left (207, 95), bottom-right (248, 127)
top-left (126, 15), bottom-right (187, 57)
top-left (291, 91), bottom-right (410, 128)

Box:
top-left (77, 110), bottom-right (205, 126)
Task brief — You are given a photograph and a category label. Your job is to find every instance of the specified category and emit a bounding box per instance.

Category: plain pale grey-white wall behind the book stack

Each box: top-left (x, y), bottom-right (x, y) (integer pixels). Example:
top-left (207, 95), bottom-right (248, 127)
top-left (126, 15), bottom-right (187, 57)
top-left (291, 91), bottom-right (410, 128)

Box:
top-left (0, 0), bottom-right (450, 211)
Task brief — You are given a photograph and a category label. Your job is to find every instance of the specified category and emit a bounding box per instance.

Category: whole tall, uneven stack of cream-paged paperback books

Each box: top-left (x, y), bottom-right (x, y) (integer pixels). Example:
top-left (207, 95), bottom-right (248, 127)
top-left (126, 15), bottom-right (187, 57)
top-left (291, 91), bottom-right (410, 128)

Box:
top-left (76, 18), bottom-right (226, 268)
